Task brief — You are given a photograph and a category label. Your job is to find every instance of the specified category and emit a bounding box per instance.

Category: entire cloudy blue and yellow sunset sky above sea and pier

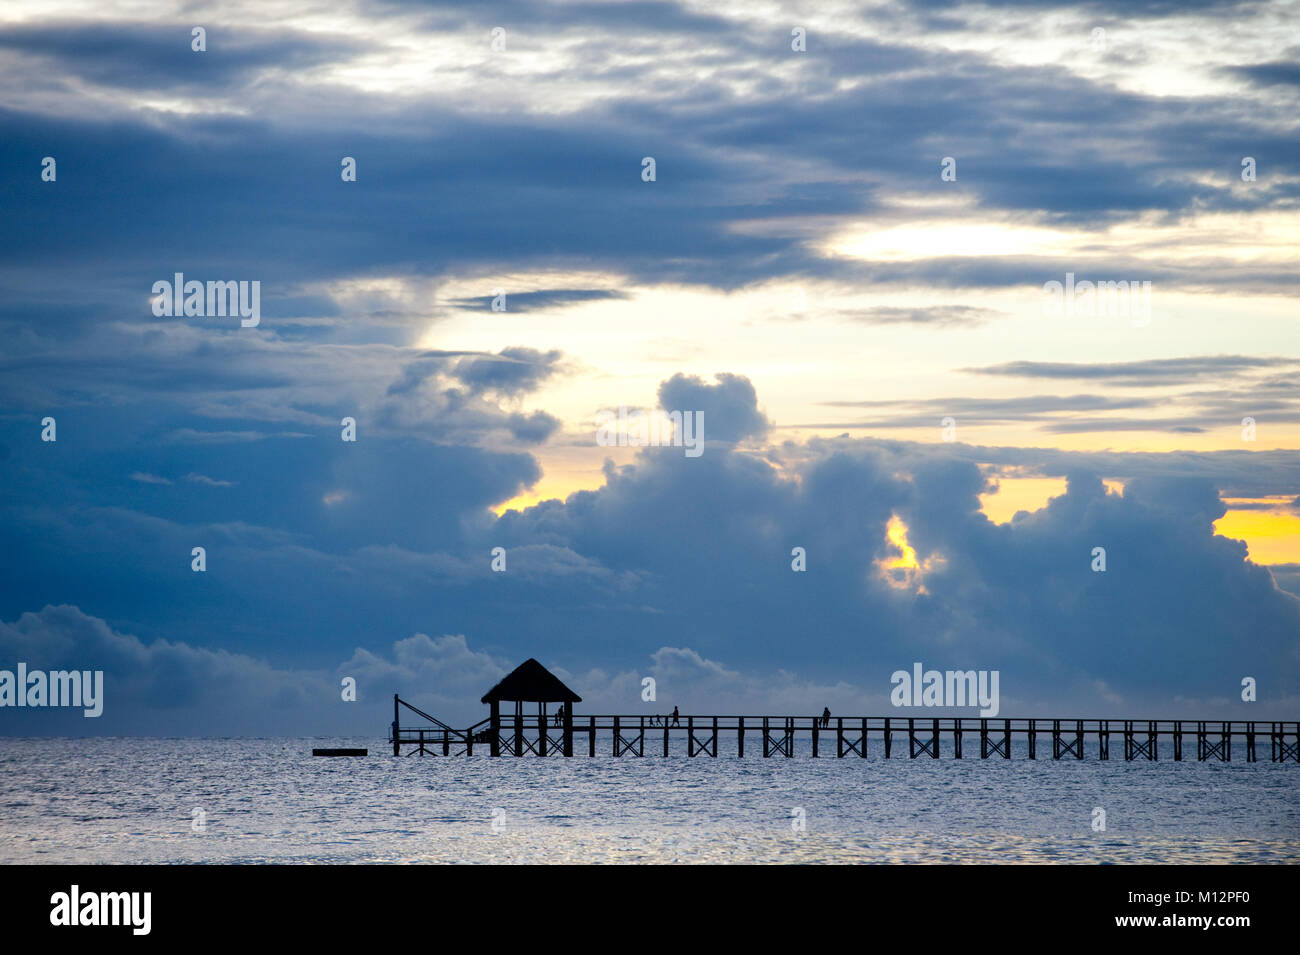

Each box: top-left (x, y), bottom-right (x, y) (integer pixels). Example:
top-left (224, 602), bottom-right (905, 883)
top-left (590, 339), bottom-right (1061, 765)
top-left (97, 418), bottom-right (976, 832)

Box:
top-left (0, 0), bottom-right (1300, 735)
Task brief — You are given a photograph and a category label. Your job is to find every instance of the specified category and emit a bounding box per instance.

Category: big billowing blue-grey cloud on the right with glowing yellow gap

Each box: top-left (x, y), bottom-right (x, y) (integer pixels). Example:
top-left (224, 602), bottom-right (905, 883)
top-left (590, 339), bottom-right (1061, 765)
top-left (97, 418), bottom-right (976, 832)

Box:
top-left (495, 423), bottom-right (1300, 711)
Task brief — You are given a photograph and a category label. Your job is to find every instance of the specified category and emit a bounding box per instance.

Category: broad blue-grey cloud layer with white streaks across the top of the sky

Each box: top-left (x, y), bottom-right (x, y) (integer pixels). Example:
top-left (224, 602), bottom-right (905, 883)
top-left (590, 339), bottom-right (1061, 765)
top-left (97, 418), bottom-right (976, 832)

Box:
top-left (0, 4), bottom-right (1297, 320)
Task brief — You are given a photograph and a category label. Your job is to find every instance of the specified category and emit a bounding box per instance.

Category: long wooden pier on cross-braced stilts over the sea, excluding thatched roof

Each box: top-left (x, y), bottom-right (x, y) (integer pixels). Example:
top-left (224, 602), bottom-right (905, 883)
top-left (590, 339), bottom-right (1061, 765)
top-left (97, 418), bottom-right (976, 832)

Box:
top-left (389, 695), bottom-right (1300, 763)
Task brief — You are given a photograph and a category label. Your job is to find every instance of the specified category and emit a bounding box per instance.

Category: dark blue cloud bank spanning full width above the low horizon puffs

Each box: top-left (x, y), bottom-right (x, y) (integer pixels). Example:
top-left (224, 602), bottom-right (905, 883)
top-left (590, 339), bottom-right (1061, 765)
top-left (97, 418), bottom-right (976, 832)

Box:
top-left (0, 376), bottom-right (1300, 732)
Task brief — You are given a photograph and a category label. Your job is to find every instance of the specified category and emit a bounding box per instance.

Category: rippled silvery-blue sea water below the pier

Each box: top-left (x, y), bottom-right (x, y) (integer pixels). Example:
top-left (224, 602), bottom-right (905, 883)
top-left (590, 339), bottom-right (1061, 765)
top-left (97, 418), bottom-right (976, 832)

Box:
top-left (0, 738), bottom-right (1300, 863)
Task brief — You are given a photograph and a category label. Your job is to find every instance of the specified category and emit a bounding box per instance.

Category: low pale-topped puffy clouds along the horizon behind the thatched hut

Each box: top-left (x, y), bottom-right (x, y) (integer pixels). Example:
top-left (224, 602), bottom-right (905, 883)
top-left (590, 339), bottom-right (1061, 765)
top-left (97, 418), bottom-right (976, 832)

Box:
top-left (0, 605), bottom-right (885, 738)
